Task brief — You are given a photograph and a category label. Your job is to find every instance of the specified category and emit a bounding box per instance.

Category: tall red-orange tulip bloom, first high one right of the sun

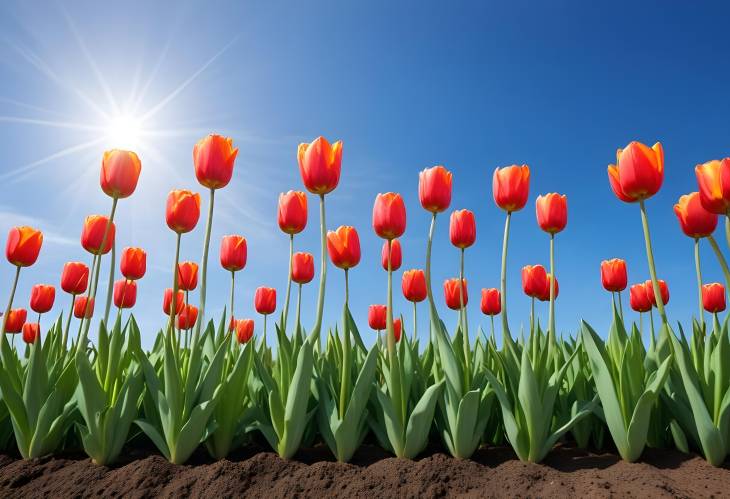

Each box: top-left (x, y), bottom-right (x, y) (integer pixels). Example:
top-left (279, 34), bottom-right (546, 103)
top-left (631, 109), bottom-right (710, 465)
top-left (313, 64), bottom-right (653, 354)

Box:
top-left (192, 134), bottom-right (238, 190)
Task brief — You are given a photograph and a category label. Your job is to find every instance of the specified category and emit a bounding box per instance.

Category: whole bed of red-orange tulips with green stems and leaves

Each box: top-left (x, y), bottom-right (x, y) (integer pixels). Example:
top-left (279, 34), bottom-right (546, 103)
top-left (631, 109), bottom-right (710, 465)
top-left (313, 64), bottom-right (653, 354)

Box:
top-left (0, 135), bottom-right (730, 488)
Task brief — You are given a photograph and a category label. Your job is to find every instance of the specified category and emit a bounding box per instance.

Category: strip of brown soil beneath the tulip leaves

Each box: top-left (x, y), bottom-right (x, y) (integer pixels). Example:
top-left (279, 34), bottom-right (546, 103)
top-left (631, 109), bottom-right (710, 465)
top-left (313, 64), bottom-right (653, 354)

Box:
top-left (0, 445), bottom-right (730, 499)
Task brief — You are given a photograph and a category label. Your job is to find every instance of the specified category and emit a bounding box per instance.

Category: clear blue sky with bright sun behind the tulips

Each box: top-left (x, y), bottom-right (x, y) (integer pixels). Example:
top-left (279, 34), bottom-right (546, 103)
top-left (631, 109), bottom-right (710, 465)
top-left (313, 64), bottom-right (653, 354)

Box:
top-left (0, 1), bottom-right (730, 348)
